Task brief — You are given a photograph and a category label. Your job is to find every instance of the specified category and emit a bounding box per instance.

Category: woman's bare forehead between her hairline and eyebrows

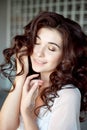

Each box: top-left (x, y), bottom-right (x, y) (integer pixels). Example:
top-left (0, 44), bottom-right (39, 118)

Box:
top-left (37, 28), bottom-right (62, 44)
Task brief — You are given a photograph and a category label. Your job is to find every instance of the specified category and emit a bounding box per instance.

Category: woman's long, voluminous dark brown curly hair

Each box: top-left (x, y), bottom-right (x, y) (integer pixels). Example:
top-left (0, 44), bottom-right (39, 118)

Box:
top-left (0, 12), bottom-right (87, 121)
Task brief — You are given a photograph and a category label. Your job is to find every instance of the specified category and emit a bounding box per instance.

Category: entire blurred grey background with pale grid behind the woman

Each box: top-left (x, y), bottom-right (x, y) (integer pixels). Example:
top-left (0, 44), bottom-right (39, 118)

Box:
top-left (0, 0), bottom-right (87, 130)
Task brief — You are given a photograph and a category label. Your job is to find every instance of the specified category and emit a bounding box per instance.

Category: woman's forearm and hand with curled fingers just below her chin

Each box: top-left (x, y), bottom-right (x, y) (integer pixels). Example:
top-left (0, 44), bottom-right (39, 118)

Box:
top-left (20, 74), bottom-right (43, 130)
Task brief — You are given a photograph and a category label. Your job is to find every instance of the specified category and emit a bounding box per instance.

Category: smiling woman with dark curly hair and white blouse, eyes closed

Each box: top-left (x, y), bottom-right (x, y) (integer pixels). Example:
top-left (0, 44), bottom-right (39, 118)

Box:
top-left (0, 12), bottom-right (87, 130)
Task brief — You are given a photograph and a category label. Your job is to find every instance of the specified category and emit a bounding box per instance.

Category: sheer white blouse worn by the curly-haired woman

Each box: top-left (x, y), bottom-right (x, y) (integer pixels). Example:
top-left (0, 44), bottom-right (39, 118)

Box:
top-left (17, 84), bottom-right (81, 130)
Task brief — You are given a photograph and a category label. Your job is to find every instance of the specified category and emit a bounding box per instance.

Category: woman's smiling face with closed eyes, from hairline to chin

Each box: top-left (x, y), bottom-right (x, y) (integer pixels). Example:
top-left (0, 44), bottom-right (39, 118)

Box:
top-left (30, 28), bottom-right (63, 74)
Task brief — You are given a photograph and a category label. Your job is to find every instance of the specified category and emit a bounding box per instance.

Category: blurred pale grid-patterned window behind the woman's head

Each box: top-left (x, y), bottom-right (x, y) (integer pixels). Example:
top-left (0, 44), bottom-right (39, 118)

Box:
top-left (10, 0), bottom-right (87, 37)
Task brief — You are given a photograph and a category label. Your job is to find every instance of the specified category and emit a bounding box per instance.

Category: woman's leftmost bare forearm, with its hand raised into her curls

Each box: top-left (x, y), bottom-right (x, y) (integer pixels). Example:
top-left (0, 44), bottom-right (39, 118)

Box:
top-left (0, 47), bottom-right (29, 130)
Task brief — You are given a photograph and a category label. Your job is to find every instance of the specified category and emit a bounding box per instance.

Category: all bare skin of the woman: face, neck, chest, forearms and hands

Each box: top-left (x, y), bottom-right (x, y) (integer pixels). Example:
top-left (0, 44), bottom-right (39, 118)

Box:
top-left (0, 28), bottom-right (62, 130)
